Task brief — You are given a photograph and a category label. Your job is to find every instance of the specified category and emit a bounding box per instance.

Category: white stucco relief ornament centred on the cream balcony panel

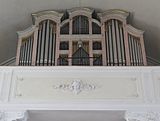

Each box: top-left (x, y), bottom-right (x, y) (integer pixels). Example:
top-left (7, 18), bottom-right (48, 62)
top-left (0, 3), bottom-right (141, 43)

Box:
top-left (53, 80), bottom-right (96, 95)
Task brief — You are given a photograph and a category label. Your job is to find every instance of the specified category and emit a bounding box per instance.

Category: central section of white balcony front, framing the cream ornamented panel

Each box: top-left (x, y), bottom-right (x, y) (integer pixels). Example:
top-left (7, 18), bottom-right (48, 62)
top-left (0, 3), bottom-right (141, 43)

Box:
top-left (10, 67), bottom-right (143, 102)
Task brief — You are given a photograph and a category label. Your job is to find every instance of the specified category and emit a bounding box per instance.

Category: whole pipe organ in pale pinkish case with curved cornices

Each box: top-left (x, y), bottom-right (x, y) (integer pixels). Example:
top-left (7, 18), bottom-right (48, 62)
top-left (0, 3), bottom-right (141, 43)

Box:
top-left (16, 8), bottom-right (147, 66)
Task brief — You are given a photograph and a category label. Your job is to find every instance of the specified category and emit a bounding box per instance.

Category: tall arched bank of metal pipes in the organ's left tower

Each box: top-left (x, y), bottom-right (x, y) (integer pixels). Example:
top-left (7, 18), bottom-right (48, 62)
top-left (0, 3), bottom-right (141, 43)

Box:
top-left (36, 20), bottom-right (56, 66)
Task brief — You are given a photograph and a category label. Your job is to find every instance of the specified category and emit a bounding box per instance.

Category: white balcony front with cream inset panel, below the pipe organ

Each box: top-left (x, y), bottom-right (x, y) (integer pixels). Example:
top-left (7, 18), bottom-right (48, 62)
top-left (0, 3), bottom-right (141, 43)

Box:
top-left (0, 66), bottom-right (160, 121)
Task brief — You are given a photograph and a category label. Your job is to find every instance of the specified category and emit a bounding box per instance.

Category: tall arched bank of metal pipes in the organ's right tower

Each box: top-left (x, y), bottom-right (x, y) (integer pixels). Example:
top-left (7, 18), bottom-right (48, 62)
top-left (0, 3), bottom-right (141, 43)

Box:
top-left (105, 19), bottom-right (126, 66)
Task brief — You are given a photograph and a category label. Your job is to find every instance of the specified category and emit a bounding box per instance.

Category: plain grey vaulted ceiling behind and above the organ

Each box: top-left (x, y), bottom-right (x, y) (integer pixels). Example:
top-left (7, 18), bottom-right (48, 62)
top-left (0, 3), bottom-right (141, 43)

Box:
top-left (0, 0), bottom-right (160, 63)
